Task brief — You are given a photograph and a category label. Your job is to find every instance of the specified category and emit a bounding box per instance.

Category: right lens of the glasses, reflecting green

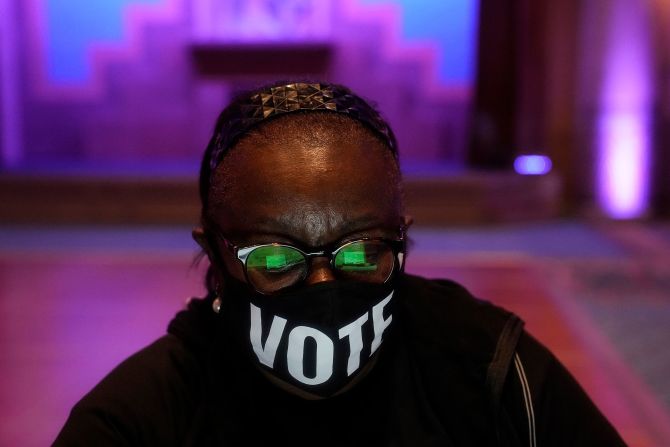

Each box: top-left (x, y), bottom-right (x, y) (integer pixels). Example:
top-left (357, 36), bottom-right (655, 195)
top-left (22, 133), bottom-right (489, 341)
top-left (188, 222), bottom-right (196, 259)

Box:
top-left (334, 241), bottom-right (395, 283)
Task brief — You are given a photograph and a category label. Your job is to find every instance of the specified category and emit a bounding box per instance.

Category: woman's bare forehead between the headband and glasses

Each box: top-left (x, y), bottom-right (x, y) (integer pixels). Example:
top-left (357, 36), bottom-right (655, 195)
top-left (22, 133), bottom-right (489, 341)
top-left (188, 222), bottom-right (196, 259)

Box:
top-left (210, 119), bottom-right (401, 245)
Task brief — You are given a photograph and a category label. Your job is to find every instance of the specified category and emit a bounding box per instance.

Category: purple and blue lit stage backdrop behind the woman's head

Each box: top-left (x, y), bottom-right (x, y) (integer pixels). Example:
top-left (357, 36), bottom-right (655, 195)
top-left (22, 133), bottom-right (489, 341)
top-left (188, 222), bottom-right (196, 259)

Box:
top-left (0, 0), bottom-right (478, 172)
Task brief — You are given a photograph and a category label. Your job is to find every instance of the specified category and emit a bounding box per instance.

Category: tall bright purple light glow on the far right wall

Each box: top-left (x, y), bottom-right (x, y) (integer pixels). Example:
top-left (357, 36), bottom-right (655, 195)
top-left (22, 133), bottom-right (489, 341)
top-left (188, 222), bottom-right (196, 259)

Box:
top-left (597, 0), bottom-right (652, 219)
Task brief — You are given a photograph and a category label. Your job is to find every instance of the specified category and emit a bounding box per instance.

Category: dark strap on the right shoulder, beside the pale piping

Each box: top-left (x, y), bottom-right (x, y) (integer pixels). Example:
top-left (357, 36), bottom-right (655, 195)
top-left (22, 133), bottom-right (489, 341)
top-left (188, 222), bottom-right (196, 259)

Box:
top-left (486, 315), bottom-right (524, 441)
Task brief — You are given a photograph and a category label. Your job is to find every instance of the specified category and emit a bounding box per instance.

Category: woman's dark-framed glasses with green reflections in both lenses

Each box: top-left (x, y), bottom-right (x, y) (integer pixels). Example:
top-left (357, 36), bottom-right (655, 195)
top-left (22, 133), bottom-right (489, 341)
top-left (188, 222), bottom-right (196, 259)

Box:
top-left (217, 228), bottom-right (405, 295)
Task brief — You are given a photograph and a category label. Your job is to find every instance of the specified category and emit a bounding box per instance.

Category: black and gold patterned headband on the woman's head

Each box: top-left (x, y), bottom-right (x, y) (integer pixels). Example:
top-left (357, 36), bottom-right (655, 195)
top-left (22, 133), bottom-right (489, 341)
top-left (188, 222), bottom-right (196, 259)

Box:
top-left (203, 82), bottom-right (398, 182)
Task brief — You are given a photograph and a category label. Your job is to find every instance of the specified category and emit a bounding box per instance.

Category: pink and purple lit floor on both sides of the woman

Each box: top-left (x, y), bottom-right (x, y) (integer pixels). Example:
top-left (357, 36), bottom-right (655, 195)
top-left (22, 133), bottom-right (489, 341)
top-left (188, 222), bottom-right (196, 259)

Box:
top-left (0, 221), bottom-right (670, 447)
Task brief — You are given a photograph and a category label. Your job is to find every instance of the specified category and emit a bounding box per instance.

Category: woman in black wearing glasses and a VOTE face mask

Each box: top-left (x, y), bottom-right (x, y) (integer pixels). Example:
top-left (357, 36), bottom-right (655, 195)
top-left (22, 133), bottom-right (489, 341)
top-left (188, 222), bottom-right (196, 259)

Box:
top-left (56, 83), bottom-right (623, 446)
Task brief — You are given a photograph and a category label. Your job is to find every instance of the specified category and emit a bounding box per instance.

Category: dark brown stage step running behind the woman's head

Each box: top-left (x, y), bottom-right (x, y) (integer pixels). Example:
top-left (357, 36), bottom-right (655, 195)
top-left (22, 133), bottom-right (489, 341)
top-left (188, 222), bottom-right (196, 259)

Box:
top-left (0, 169), bottom-right (561, 226)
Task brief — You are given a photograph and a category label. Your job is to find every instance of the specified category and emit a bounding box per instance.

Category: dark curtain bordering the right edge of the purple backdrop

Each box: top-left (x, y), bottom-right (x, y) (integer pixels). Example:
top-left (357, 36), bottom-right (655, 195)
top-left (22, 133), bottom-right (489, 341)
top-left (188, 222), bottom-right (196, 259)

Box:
top-left (468, 0), bottom-right (546, 169)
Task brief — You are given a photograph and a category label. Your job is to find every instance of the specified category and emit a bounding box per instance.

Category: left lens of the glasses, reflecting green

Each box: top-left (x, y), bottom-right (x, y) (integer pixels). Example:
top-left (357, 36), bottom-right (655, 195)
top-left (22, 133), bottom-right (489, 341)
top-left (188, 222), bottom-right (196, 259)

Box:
top-left (246, 245), bottom-right (307, 293)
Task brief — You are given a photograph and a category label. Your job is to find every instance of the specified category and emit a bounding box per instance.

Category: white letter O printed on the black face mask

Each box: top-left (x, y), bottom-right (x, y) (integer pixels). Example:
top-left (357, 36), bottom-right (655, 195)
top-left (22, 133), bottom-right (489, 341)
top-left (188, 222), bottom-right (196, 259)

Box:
top-left (286, 326), bottom-right (334, 385)
